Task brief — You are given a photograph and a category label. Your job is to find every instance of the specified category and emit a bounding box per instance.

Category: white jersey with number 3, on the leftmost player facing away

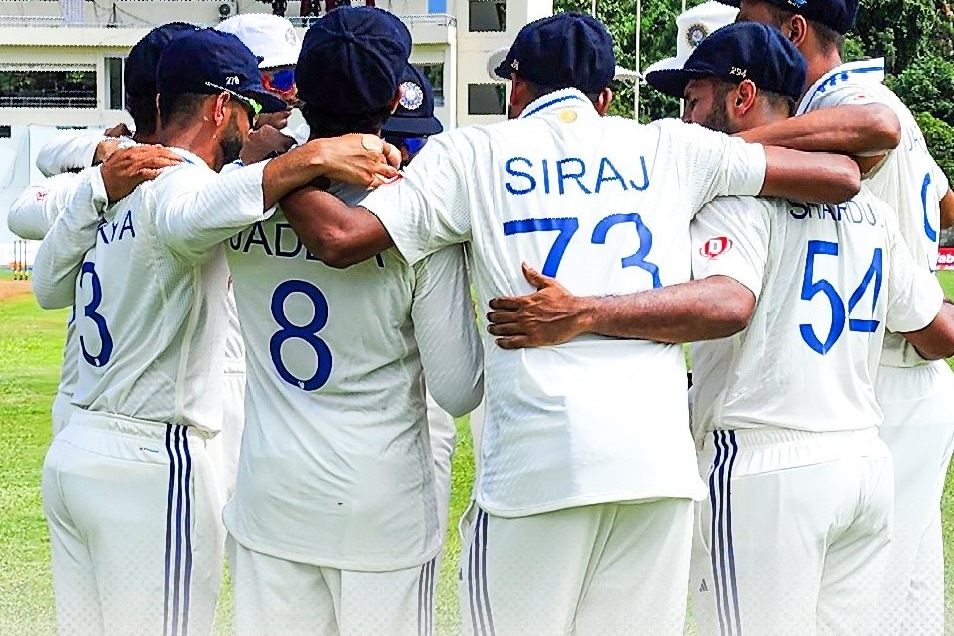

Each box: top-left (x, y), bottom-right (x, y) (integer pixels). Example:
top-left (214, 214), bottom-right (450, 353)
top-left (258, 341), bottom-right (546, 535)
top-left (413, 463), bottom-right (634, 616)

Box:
top-left (36, 149), bottom-right (274, 433)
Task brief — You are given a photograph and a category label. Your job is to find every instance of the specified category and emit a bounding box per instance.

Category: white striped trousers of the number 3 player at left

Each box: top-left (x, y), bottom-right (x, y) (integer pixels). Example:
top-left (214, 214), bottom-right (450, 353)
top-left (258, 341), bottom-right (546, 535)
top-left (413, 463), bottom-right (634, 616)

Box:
top-left (42, 408), bottom-right (224, 636)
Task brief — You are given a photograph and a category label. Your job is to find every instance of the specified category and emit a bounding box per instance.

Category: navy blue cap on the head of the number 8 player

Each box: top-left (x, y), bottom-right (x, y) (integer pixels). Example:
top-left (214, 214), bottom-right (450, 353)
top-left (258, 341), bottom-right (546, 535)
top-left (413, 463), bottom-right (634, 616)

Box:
top-left (295, 7), bottom-right (411, 115)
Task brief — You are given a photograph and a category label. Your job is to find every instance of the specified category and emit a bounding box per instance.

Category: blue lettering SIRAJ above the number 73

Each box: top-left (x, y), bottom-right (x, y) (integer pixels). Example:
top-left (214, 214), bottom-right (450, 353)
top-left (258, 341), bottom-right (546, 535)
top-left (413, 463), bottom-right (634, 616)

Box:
top-left (504, 156), bottom-right (649, 195)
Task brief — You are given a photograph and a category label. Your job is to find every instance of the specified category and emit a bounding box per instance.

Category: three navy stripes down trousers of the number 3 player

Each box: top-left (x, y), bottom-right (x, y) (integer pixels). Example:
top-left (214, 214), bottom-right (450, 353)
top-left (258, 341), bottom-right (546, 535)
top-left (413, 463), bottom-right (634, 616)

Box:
top-left (162, 424), bottom-right (192, 636)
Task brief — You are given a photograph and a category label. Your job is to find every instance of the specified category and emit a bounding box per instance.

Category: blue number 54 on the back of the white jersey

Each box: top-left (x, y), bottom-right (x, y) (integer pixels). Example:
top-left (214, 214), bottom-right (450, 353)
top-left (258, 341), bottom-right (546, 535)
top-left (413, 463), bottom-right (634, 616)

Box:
top-left (798, 241), bottom-right (882, 355)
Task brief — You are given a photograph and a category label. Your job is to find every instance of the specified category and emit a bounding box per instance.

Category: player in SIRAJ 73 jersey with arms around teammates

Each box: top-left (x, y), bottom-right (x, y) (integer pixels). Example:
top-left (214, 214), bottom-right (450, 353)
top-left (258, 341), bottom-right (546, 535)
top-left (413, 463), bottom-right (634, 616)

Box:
top-left (274, 13), bottom-right (858, 635)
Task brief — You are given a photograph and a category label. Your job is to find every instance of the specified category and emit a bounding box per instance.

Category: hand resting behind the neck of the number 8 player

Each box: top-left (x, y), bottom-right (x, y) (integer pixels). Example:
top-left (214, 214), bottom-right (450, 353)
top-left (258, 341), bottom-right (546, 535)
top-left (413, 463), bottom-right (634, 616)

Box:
top-left (302, 133), bottom-right (401, 187)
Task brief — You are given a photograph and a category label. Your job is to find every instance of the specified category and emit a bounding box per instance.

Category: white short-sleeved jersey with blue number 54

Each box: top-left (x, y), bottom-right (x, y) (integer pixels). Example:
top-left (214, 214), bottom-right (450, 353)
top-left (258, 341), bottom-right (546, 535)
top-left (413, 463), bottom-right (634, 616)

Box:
top-left (690, 190), bottom-right (943, 435)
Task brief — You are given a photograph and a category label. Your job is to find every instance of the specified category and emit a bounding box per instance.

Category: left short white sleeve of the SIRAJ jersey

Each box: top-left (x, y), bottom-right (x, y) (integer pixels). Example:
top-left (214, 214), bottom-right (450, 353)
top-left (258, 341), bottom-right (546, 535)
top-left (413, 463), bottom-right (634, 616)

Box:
top-left (361, 131), bottom-right (474, 265)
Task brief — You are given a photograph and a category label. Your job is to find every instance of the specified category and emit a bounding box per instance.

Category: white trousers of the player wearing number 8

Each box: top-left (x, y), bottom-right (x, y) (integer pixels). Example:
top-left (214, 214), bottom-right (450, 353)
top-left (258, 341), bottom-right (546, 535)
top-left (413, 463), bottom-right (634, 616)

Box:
top-left (228, 536), bottom-right (437, 636)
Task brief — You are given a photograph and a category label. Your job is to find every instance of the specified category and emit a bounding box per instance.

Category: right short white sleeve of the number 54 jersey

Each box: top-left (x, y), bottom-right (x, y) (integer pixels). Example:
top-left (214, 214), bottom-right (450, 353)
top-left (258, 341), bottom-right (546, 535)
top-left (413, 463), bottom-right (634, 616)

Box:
top-left (883, 205), bottom-right (944, 333)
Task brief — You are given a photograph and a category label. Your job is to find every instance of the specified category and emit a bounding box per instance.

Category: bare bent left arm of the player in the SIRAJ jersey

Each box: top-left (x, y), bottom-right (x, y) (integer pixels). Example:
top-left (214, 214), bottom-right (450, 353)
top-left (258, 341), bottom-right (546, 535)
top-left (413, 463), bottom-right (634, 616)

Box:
top-left (281, 188), bottom-right (393, 268)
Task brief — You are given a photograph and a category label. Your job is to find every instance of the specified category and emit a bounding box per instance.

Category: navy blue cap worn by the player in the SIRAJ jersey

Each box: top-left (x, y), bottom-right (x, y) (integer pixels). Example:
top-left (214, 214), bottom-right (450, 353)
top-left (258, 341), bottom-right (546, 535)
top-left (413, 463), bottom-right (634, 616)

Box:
top-left (494, 13), bottom-right (616, 94)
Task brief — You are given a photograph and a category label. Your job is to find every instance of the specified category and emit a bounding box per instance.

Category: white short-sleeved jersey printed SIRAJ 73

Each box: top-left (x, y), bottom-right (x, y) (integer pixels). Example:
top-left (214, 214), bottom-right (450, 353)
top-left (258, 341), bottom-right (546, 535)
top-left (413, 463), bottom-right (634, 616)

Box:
top-left (362, 89), bottom-right (765, 516)
